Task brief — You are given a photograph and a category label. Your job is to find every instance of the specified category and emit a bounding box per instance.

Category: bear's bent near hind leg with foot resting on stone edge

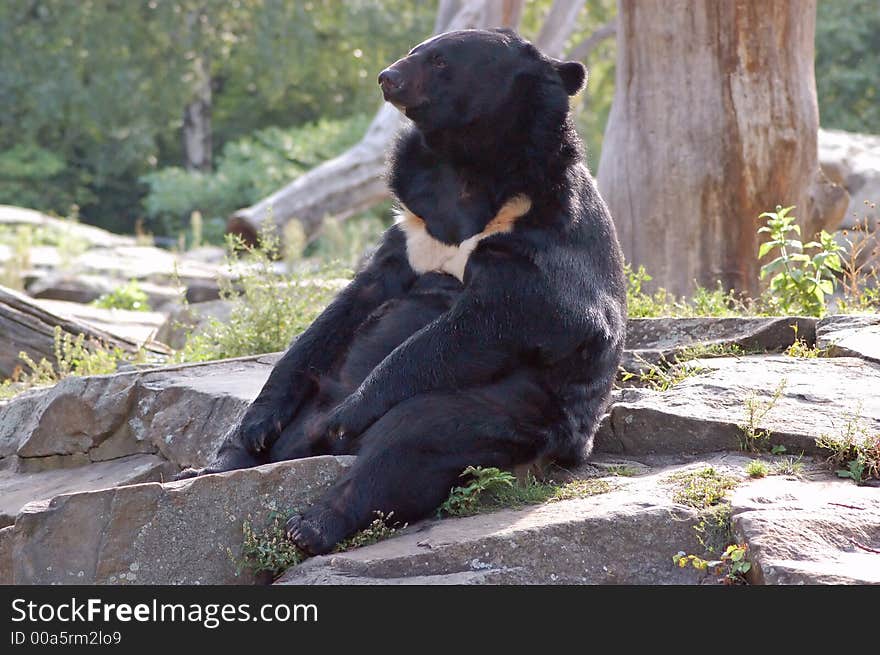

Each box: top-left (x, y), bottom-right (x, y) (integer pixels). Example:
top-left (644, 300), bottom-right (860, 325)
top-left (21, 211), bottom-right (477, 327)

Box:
top-left (287, 385), bottom-right (547, 555)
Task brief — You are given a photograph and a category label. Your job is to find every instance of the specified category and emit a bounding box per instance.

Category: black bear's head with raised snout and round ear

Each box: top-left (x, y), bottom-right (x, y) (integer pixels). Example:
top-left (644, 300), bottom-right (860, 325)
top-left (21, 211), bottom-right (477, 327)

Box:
top-left (379, 29), bottom-right (586, 133)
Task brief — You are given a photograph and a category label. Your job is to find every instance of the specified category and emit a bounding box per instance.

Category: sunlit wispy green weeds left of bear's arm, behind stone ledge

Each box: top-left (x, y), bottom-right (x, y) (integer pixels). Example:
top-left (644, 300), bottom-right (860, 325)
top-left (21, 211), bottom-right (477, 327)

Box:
top-left (177, 231), bottom-right (351, 362)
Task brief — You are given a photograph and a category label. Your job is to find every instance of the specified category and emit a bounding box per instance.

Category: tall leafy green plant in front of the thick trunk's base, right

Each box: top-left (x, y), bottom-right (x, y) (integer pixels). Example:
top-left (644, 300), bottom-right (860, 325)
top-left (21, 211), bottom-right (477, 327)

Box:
top-left (758, 205), bottom-right (843, 316)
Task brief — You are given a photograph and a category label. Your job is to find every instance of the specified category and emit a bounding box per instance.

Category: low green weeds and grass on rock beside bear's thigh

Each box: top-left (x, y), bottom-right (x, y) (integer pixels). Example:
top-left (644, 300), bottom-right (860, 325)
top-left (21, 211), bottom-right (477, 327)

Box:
top-left (437, 466), bottom-right (613, 517)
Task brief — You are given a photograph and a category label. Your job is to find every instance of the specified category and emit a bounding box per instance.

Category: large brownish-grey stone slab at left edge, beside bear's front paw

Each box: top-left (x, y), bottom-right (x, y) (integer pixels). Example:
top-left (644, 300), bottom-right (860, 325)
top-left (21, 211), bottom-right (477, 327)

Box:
top-left (0, 355), bottom-right (277, 468)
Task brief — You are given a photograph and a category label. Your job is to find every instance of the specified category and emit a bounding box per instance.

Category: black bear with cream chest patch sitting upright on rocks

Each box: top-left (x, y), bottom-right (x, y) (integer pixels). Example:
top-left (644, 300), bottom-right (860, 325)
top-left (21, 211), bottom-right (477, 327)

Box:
top-left (181, 30), bottom-right (626, 554)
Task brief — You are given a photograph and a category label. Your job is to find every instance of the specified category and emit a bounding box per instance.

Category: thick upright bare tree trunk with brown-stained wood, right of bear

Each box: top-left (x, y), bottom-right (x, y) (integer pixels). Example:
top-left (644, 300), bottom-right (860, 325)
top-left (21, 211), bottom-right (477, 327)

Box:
top-left (598, 0), bottom-right (846, 295)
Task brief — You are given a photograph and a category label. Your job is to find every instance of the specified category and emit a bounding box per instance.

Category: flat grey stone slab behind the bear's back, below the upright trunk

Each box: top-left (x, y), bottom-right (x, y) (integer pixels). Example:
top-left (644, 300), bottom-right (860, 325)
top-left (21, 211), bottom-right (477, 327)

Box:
top-left (621, 316), bottom-right (816, 373)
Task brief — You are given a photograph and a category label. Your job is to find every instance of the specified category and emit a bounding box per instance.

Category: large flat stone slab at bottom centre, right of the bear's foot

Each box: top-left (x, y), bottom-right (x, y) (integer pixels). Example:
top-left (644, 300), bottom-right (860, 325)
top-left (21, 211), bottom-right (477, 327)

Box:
top-left (276, 469), bottom-right (720, 585)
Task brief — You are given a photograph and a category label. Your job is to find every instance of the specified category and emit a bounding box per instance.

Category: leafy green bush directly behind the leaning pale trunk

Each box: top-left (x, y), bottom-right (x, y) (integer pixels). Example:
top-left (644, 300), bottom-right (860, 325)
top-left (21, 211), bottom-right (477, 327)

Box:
top-left (142, 115), bottom-right (369, 240)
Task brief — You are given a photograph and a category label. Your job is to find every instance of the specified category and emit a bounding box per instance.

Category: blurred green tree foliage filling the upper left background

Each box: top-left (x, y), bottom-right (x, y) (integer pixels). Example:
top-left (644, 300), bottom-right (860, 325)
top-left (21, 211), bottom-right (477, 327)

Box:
top-left (0, 0), bottom-right (436, 234)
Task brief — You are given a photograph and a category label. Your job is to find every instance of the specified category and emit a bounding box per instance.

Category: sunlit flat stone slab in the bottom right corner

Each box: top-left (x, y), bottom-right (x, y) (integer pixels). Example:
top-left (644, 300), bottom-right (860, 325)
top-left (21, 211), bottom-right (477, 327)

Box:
top-left (732, 477), bottom-right (880, 584)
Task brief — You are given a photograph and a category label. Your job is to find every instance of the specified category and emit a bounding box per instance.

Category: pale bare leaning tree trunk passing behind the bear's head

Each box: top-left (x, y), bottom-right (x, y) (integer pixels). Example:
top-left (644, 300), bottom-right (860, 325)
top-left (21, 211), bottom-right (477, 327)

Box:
top-left (227, 0), bottom-right (532, 242)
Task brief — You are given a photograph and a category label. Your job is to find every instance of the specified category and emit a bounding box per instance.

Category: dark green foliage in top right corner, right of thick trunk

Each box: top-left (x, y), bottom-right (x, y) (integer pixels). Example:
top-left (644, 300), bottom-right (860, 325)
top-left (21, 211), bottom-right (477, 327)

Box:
top-left (816, 0), bottom-right (880, 133)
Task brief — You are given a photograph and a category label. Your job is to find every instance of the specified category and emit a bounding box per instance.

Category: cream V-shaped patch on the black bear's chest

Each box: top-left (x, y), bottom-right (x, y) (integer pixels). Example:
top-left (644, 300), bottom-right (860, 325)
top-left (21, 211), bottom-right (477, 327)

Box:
top-left (397, 196), bottom-right (532, 281)
